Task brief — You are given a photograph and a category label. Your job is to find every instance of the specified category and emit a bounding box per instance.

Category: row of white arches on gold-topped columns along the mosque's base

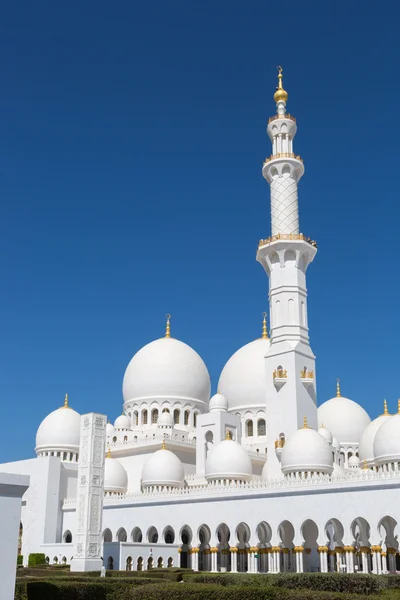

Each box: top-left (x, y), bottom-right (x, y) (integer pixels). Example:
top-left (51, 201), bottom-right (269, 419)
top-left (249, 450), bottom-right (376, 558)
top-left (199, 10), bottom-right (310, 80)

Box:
top-left (104, 515), bottom-right (400, 574)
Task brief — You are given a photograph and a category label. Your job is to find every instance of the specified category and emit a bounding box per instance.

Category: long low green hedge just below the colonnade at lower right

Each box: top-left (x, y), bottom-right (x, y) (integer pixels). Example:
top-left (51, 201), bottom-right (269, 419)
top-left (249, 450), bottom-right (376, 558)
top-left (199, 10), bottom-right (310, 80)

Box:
top-left (185, 573), bottom-right (384, 600)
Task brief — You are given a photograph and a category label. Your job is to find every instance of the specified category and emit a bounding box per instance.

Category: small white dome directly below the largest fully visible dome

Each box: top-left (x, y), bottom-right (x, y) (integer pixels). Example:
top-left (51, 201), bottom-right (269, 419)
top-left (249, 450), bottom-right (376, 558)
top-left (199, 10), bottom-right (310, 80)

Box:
top-left (142, 448), bottom-right (185, 487)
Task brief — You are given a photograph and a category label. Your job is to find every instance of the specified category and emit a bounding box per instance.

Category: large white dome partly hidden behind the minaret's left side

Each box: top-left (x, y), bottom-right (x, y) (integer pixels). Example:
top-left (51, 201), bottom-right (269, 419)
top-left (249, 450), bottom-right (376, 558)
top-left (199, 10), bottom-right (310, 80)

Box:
top-left (218, 338), bottom-right (270, 411)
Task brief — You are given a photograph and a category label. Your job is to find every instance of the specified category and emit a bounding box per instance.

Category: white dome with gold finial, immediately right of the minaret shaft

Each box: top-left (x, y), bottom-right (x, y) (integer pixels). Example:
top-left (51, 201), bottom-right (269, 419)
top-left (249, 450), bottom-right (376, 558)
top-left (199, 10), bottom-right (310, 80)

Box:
top-left (318, 390), bottom-right (371, 445)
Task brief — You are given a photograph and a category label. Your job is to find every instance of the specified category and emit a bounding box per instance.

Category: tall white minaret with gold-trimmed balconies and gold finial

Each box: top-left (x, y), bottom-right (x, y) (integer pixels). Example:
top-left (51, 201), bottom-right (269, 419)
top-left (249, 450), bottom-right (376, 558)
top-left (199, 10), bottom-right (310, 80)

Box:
top-left (257, 67), bottom-right (317, 477)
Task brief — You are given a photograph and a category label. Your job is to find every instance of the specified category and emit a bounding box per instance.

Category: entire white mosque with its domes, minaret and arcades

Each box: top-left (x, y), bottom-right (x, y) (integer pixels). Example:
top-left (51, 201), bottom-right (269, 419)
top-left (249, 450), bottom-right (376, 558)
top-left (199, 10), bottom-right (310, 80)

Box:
top-left (0, 69), bottom-right (400, 574)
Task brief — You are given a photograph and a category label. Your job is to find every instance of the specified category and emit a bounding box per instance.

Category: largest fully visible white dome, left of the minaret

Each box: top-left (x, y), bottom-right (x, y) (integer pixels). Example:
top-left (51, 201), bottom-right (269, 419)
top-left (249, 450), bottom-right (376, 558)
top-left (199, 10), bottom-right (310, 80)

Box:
top-left (122, 337), bottom-right (211, 403)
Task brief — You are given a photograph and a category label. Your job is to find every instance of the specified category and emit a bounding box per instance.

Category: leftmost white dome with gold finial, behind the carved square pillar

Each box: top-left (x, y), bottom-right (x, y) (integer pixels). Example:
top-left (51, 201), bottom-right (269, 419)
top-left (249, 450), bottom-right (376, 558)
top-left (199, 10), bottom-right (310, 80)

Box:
top-left (35, 396), bottom-right (81, 454)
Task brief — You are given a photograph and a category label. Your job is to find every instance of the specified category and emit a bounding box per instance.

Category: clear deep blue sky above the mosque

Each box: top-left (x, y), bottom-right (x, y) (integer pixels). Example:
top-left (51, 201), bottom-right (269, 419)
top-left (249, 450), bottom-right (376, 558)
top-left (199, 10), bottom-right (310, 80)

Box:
top-left (0, 0), bottom-right (400, 462)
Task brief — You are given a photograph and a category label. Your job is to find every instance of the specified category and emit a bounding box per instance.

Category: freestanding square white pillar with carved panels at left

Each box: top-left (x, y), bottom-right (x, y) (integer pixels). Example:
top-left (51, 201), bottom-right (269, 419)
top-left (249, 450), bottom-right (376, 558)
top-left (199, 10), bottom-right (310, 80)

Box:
top-left (70, 409), bottom-right (105, 571)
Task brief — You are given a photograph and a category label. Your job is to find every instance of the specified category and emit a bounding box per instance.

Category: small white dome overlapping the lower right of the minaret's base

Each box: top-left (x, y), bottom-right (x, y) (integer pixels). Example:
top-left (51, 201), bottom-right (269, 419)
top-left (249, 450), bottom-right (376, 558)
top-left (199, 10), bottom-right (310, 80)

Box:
top-left (281, 427), bottom-right (333, 475)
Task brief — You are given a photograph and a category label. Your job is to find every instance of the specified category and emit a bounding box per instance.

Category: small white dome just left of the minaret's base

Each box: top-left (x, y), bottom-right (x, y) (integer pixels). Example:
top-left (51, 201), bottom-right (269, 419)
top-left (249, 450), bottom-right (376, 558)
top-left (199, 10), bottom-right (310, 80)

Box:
top-left (205, 438), bottom-right (252, 481)
